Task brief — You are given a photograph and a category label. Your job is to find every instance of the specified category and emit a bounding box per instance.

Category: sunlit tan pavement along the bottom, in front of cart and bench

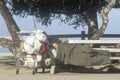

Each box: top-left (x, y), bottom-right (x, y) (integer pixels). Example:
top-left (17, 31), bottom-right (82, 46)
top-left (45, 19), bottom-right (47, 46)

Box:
top-left (0, 62), bottom-right (120, 80)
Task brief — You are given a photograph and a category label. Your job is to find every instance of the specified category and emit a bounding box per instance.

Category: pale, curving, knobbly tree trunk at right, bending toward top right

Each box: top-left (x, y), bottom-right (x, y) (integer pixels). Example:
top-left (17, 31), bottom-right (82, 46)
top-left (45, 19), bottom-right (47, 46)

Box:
top-left (90, 0), bottom-right (116, 39)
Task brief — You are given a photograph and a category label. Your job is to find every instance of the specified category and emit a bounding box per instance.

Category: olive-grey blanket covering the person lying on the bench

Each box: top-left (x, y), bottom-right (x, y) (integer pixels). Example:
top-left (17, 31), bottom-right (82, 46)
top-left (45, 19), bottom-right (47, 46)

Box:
top-left (56, 43), bottom-right (110, 66)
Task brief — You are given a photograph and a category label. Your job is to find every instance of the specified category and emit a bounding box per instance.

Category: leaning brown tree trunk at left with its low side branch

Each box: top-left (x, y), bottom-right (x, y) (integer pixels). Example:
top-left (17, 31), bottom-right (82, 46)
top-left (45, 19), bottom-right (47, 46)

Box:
top-left (0, 0), bottom-right (20, 53)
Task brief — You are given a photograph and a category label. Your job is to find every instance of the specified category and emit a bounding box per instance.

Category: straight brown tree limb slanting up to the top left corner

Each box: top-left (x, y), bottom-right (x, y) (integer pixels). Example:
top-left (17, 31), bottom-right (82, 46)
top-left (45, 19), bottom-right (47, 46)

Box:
top-left (0, 0), bottom-right (20, 45)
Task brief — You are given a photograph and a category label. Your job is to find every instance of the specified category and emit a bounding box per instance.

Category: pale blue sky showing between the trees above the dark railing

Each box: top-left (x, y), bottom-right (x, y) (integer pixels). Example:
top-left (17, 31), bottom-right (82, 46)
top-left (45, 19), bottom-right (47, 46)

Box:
top-left (0, 9), bottom-right (120, 52)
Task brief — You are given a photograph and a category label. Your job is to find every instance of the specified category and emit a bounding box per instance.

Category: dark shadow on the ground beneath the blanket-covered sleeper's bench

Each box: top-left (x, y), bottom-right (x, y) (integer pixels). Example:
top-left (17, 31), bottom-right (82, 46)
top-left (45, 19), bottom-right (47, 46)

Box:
top-left (57, 65), bottom-right (120, 74)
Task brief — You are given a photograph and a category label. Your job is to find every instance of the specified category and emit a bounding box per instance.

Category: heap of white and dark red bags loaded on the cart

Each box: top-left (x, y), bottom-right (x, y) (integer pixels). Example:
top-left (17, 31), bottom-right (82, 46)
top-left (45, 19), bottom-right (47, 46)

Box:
top-left (23, 30), bottom-right (48, 67)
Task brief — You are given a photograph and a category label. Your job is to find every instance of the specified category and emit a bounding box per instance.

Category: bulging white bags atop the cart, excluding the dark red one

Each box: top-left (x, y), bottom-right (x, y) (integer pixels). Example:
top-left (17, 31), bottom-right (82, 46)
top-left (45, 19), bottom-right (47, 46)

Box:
top-left (23, 30), bottom-right (48, 54)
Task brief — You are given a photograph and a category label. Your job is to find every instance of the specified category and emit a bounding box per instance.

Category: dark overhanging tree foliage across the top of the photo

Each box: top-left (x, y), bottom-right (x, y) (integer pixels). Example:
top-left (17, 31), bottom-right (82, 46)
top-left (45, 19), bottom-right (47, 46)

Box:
top-left (4, 0), bottom-right (118, 28)
